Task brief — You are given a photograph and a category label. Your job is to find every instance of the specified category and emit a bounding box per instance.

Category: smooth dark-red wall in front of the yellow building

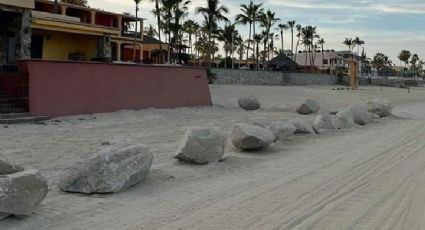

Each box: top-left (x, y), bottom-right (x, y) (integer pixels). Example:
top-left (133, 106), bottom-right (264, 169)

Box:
top-left (25, 60), bottom-right (212, 116)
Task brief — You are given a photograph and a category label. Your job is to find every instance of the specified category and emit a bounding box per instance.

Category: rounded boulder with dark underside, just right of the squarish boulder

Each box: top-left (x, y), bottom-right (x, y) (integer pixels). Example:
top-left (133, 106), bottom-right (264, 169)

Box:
top-left (232, 123), bottom-right (275, 150)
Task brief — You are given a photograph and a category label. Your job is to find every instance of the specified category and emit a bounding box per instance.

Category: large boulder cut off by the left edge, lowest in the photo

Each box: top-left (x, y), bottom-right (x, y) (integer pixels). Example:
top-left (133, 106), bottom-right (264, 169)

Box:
top-left (0, 170), bottom-right (48, 218)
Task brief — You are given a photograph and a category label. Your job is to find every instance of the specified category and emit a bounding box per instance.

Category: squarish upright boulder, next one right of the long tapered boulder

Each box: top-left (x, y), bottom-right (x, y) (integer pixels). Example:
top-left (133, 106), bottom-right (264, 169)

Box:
top-left (176, 128), bottom-right (226, 164)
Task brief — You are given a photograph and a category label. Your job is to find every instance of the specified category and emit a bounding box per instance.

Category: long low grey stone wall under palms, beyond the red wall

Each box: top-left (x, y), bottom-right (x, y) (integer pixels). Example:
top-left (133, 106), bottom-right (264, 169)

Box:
top-left (212, 69), bottom-right (337, 85)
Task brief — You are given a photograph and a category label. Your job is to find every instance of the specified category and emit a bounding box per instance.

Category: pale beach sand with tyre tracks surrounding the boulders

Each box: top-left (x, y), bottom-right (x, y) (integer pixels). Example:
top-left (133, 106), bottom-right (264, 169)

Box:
top-left (0, 86), bottom-right (425, 230)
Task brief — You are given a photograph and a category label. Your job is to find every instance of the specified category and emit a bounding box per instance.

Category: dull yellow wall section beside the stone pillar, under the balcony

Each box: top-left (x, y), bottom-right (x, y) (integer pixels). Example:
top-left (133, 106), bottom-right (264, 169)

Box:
top-left (43, 32), bottom-right (97, 61)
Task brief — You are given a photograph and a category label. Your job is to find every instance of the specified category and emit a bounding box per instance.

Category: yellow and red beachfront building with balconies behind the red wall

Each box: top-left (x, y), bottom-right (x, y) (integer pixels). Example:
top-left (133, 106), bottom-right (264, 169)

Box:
top-left (0, 0), bottom-right (168, 63)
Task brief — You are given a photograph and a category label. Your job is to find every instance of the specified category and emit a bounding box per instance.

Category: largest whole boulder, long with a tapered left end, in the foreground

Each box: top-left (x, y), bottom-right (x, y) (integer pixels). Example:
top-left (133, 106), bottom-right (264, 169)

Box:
top-left (60, 144), bottom-right (153, 194)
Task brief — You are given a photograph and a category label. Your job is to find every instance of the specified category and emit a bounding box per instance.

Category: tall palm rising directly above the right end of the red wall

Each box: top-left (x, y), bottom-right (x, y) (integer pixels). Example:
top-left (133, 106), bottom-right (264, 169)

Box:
top-left (195, 0), bottom-right (229, 68)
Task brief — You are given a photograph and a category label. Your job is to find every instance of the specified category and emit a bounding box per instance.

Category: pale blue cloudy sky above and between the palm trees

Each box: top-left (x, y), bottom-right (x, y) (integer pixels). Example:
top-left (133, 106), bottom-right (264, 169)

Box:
top-left (89, 0), bottom-right (425, 64)
